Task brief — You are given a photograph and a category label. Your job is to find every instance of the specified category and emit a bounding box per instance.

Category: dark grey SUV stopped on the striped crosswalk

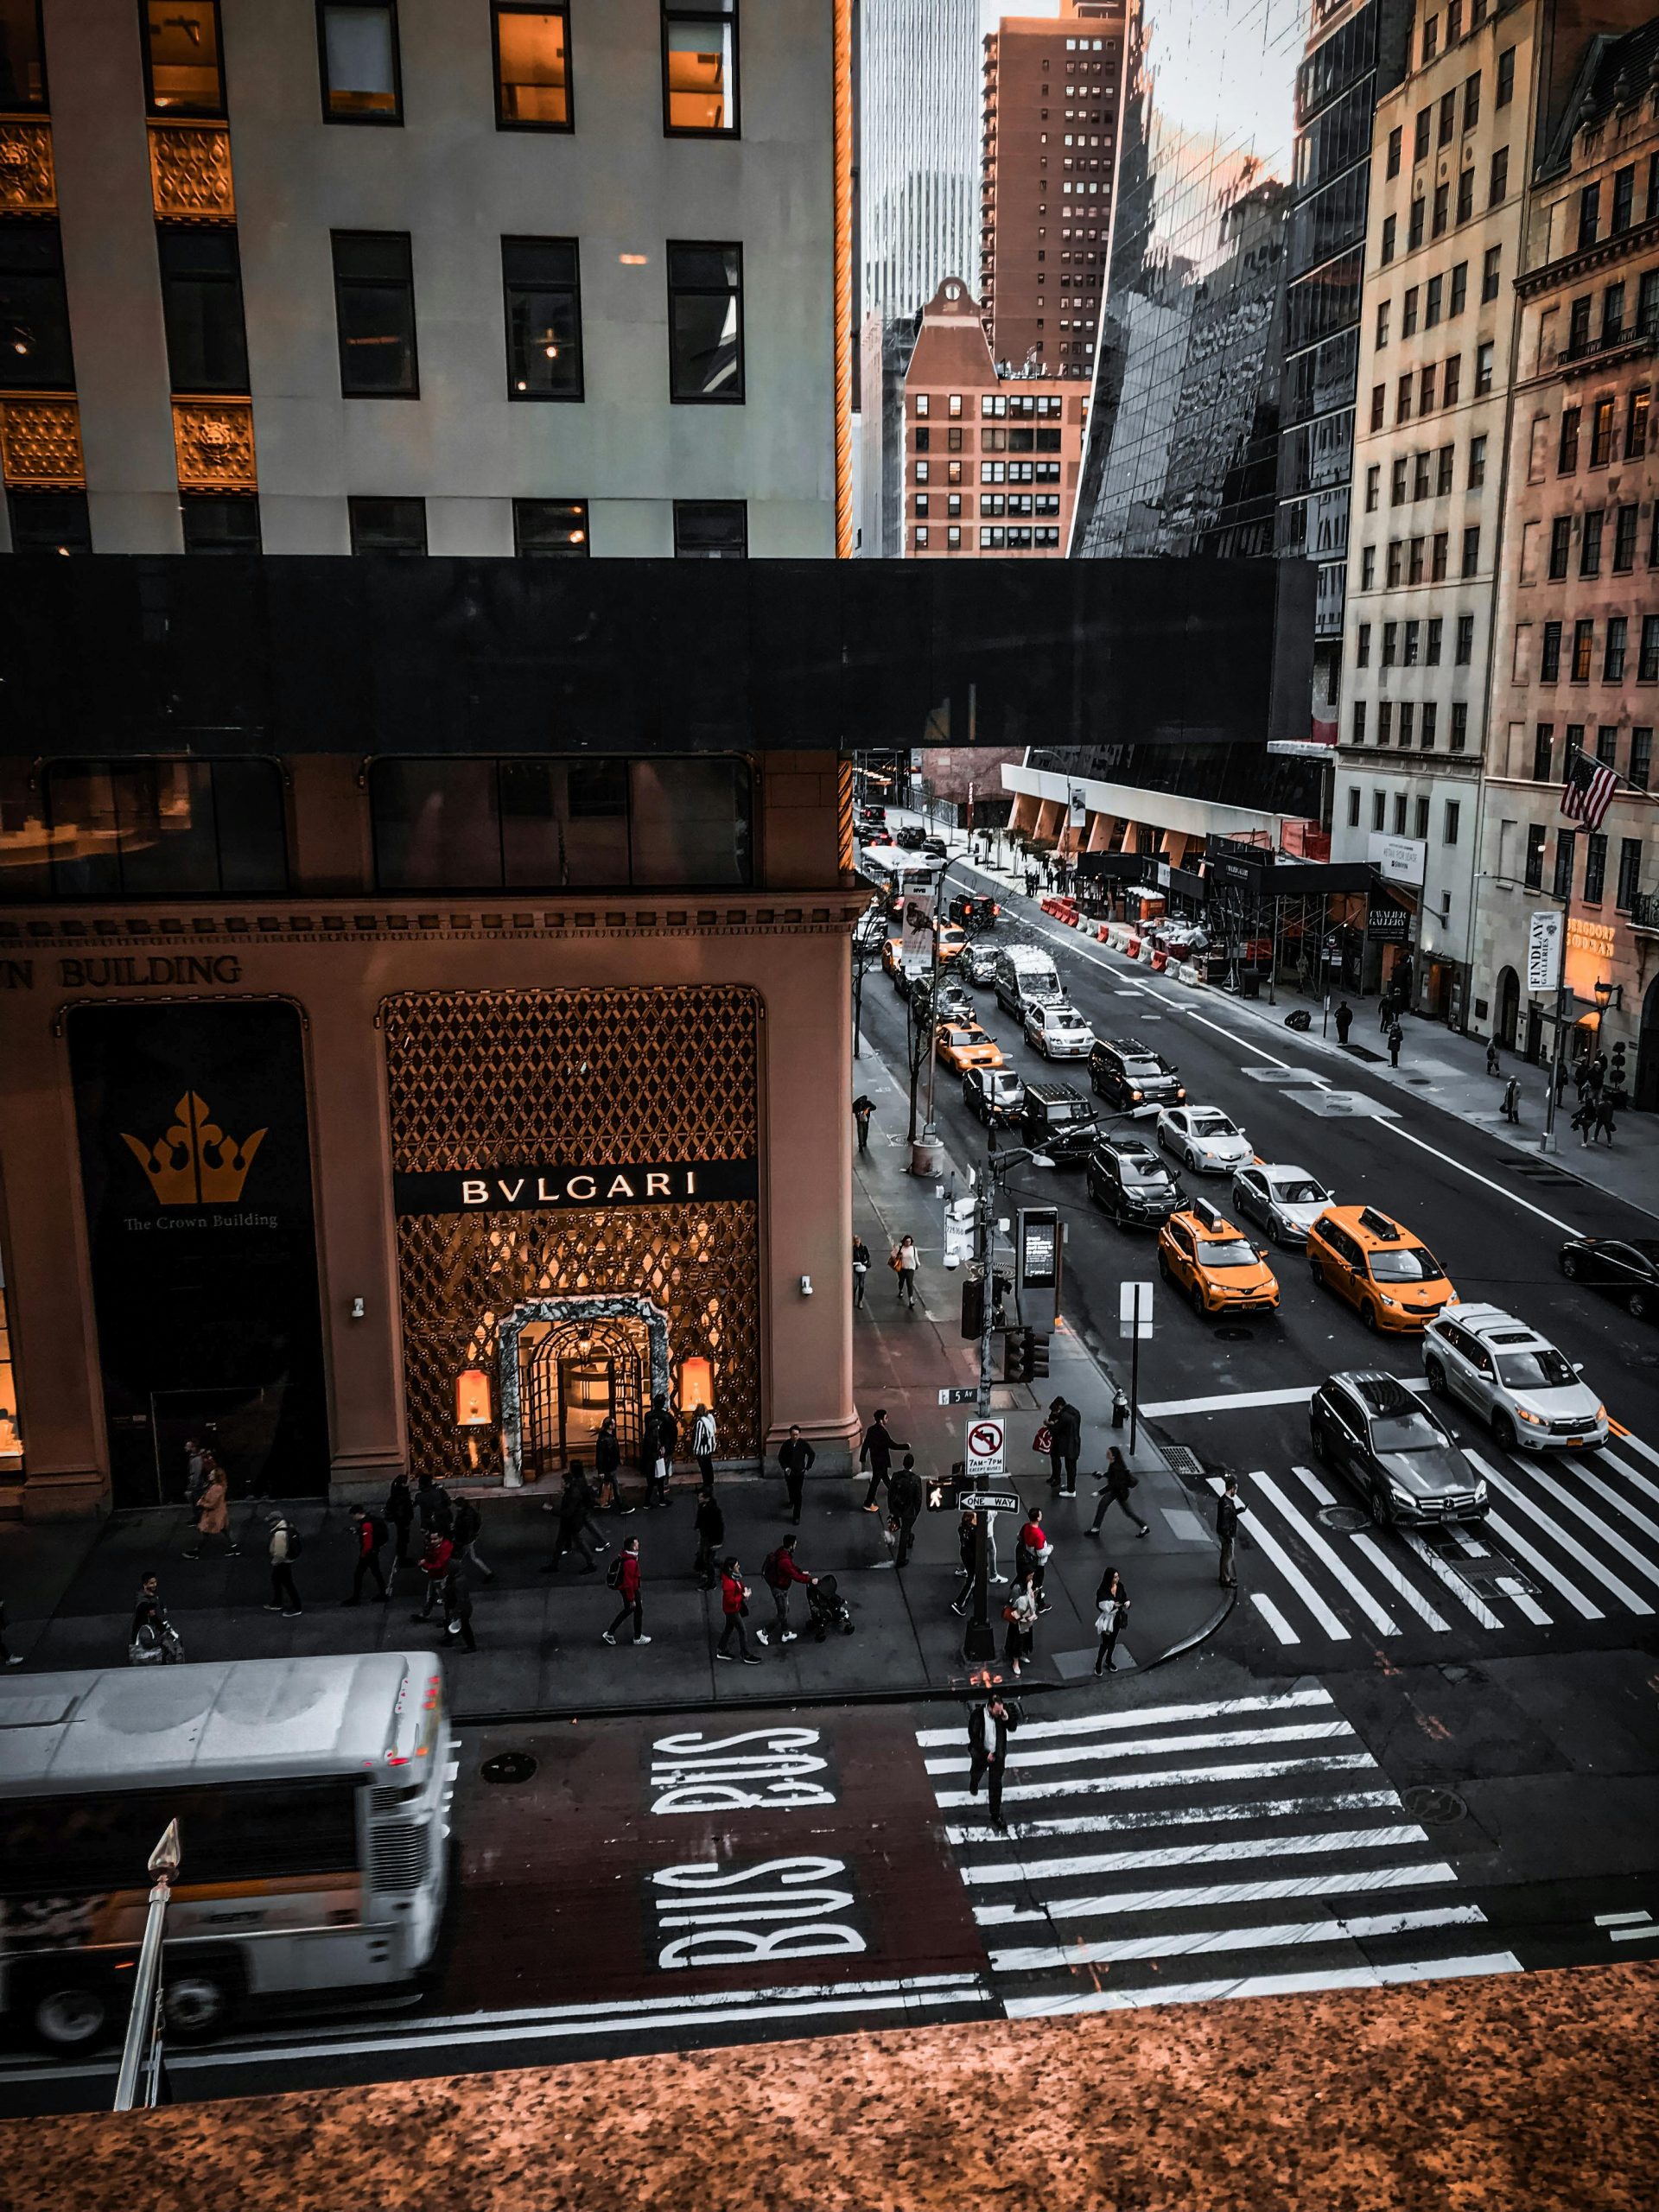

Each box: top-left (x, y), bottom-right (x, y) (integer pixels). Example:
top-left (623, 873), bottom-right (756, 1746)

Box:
top-left (1307, 1370), bottom-right (1489, 1529)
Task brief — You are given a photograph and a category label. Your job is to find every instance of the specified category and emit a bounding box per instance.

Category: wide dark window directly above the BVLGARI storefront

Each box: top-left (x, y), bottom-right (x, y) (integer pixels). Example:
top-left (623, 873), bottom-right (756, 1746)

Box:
top-left (370, 754), bottom-right (752, 892)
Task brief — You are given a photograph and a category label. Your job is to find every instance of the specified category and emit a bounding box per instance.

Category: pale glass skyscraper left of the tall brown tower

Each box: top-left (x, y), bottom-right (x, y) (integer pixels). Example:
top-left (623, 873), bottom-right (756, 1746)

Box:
top-left (858, 0), bottom-right (980, 321)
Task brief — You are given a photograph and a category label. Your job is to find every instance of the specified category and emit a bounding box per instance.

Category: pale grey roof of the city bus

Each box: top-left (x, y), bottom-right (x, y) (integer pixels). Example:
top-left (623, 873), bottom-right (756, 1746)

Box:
top-left (0, 1652), bottom-right (422, 1794)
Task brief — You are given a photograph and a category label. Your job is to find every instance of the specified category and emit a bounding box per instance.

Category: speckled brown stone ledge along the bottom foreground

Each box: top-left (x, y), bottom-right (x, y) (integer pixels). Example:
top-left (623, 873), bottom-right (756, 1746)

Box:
top-left (0, 1964), bottom-right (1659, 2212)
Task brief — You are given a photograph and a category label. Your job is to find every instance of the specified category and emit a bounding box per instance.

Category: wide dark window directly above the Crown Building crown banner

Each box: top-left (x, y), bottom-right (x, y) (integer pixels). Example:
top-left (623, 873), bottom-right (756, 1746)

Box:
top-left (44, 759), bottom-right (288, 898)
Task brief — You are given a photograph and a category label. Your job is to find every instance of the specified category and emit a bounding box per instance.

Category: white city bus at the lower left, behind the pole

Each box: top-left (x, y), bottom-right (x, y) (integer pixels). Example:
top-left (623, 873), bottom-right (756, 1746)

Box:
top-left (0, 1652), bottom-right (454, 2053)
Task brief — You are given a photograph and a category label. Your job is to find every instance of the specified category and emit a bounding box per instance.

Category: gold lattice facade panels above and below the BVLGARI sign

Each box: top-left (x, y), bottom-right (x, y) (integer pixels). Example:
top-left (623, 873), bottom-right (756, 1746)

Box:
top-left (380, 984), bottom-right (763, 1473)
